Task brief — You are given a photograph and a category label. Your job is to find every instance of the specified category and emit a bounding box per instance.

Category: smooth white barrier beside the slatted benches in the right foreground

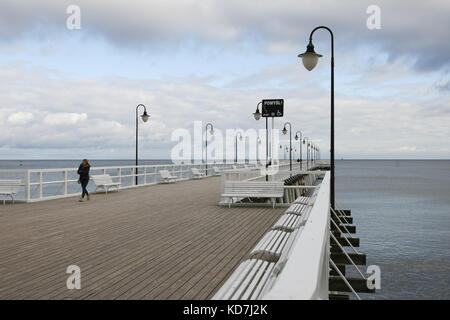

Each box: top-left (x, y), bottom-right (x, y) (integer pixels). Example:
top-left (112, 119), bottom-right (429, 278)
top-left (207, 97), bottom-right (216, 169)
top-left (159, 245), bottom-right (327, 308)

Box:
top-left (262, 172), bottom-right (330, 300)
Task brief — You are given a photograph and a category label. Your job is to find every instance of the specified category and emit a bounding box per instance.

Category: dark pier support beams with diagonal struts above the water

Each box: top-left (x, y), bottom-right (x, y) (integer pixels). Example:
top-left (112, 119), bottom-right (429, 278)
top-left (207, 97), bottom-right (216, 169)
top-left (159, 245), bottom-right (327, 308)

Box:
top-left (329, 207), bottom-right (375, 300)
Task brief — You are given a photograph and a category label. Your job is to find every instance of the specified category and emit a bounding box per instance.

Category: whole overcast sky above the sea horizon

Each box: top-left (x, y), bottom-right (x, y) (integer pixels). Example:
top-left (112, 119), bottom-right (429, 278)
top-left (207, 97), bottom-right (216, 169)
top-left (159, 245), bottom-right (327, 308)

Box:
top-left (0, 0), bottom-right (450, 159)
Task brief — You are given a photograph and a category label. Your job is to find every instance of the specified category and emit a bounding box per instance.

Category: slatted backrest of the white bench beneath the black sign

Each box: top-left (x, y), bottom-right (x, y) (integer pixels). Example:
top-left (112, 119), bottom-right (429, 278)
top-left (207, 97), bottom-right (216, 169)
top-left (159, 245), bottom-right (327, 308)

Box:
top-left (224, 181), bottom-right (284, 197)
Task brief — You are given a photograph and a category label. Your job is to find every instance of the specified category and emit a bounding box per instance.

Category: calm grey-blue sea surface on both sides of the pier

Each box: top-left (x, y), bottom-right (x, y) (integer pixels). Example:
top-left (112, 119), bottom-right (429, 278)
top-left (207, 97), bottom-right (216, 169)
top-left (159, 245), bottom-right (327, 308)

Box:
top-left (0, 160), bottom-right (450, 299)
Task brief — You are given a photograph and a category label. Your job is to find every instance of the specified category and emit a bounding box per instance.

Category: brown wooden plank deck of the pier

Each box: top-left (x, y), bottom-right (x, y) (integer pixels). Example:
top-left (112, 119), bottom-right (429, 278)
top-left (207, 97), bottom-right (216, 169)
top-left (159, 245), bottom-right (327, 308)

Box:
top-left (0, 178), bottom-right (285, 299)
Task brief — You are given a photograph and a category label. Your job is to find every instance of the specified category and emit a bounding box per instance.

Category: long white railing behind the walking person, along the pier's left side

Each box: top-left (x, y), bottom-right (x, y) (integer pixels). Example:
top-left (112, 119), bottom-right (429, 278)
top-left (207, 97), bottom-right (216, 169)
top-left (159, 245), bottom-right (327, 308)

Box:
top-left (0, 162), bottom-right (258, 202)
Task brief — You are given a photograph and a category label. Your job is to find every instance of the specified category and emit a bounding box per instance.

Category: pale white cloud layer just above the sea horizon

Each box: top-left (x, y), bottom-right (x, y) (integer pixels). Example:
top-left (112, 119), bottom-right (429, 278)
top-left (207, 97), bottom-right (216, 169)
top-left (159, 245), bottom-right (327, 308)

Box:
top-left (0, 63), bottom-right (450, 158)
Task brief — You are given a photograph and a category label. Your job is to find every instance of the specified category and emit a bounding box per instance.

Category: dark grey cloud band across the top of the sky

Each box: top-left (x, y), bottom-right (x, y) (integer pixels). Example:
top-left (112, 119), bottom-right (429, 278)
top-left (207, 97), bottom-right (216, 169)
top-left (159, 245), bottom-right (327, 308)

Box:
top-left (0, 0), bottom-right (450, 71)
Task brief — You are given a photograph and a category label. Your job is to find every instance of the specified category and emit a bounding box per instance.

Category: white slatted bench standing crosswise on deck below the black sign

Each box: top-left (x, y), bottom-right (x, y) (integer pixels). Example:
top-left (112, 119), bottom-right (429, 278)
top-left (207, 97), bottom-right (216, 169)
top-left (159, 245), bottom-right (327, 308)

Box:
top-left (222, 181), bottom-right (284, 207)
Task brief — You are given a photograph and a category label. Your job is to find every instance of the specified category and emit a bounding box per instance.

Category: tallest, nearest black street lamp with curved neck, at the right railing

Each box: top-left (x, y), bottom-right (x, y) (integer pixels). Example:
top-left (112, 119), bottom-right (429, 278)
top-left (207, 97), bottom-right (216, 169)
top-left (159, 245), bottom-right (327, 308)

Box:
top-left (298, 26), bottom-right (335, 209)
